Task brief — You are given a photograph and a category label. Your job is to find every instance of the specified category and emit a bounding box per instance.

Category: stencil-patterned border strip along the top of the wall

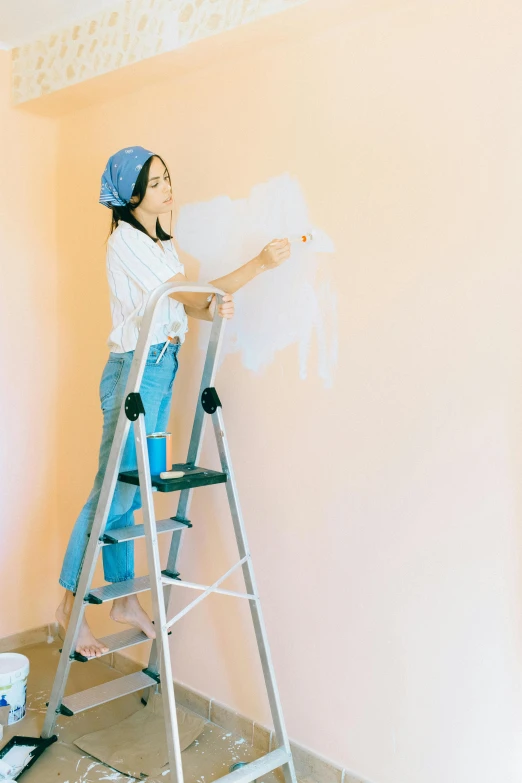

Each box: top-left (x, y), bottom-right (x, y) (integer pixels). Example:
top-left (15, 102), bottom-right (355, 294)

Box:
top-left (12, 0), bottom-right (308, 104)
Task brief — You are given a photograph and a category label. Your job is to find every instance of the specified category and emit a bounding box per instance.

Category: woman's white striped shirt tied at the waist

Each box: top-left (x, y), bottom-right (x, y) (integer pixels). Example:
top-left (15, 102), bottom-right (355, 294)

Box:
top-left (107, 221), bottom-right (188, 353)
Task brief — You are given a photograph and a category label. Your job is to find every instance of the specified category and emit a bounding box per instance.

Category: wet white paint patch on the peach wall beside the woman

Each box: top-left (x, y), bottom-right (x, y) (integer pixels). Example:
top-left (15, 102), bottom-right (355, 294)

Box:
top-left (176, 174), bottom-right (338, 386)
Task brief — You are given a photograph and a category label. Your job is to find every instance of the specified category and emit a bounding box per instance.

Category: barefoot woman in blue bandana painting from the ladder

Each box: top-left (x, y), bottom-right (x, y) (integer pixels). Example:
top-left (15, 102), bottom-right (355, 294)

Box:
top-left (56, 147), bottom-right (290, 658)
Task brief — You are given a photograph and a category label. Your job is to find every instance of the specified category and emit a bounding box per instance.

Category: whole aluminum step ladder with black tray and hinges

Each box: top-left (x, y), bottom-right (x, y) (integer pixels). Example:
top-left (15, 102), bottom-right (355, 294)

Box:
top-left (42, 283), bottom-right (297, 783)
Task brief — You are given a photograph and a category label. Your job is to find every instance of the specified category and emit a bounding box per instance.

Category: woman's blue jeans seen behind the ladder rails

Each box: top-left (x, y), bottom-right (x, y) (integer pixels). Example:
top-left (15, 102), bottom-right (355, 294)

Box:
top-left (60, 344), bottom-right (179, 593)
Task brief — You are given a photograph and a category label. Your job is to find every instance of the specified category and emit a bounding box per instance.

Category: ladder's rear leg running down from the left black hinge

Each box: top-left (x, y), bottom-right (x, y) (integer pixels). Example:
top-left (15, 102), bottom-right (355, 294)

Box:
top-left (134, 415), bottom-right (183, 783)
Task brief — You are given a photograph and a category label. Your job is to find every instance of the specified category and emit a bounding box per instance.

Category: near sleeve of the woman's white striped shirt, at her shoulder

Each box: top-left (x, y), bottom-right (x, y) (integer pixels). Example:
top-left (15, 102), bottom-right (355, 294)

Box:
top-left (108, 230), bottom-right (183, 292)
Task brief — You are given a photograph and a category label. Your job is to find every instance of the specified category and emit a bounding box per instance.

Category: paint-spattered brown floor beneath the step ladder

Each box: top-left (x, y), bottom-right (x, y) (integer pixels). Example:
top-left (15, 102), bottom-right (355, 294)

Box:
top-left (0, 642), bottom-right (277, 783)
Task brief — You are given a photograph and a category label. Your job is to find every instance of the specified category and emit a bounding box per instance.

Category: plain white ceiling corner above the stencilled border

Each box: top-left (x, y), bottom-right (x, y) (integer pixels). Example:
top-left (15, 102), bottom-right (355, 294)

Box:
top-left (0, 0), bottom-right (119, 49)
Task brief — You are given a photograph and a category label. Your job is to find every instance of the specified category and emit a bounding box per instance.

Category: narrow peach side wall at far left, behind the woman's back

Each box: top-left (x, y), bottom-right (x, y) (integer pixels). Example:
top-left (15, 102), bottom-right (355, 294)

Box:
top-left (0, 51), bottom-right (59, 636)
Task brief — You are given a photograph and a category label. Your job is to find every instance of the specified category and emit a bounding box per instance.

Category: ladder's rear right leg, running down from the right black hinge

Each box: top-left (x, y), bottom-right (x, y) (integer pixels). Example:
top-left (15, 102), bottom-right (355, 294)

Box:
top-left (208, 407), bottom-right (296, 783)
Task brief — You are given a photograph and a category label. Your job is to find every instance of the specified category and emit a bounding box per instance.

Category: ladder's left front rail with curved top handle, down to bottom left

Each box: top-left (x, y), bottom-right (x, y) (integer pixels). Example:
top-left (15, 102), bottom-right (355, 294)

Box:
top-left (42, 282), bottom-right (222, 738)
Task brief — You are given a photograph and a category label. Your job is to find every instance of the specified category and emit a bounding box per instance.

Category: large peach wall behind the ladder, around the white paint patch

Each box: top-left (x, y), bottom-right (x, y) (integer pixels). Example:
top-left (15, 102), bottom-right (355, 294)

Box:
top-left (37, 0), bottom-right (522, 783)
